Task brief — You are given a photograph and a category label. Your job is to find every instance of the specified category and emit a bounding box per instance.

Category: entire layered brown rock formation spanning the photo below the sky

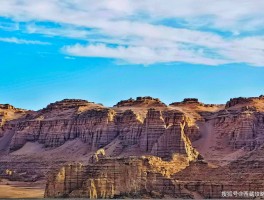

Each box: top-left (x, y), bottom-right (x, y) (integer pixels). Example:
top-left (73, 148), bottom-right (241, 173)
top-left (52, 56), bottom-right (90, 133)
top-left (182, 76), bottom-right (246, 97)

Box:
top-left (0, 96), bottom-right (264, 199)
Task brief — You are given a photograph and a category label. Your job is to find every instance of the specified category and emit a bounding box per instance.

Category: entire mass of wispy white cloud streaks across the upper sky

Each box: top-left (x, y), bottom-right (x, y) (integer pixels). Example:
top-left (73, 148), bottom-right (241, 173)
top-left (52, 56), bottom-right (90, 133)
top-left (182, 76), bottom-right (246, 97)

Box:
top-left (0, 0), bottom-right (264, 66)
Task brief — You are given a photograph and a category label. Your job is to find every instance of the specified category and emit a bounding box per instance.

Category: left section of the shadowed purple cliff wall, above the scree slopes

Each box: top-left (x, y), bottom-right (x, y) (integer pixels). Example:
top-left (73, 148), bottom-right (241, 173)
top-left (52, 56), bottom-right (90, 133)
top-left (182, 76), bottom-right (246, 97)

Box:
top-left (10, 109), bottom-right (116, 150)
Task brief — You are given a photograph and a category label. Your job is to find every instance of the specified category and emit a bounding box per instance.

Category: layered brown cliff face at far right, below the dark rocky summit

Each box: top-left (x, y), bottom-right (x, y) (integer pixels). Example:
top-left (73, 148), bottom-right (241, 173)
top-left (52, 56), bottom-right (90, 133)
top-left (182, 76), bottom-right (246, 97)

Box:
top-left (213, 107), bottom-right (264, 150)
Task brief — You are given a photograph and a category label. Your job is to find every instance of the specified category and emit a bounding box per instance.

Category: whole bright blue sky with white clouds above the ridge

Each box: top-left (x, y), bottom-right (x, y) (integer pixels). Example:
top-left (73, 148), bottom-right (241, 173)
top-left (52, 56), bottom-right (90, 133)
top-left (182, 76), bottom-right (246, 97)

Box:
top-left (0, 0), bottom-right (264, 110)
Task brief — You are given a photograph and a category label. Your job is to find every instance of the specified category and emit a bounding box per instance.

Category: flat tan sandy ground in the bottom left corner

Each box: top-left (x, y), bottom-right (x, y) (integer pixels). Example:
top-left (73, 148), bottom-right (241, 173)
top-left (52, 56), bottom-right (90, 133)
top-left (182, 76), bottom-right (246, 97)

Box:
top-left (0, 180), bottom-right (45, 198)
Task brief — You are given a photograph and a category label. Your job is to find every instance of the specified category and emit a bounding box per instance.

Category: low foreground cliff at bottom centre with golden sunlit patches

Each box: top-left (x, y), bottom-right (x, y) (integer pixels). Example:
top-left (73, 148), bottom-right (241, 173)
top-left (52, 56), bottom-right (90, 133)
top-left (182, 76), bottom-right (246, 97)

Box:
top-left (45, 157), bottom-right (196, 198)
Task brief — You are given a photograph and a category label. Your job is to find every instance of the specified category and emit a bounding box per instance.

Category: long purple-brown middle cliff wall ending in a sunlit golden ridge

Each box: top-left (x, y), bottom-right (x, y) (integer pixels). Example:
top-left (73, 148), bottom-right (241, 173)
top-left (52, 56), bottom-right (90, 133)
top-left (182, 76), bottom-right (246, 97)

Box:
top-left (4, 100), bottom-right (198, 159)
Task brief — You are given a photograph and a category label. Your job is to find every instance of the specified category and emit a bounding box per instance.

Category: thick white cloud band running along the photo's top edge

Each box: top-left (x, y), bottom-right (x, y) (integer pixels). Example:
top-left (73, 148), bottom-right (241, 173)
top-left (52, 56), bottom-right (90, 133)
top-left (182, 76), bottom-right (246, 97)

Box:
top-left (0, 0), bottom-right (264, 30)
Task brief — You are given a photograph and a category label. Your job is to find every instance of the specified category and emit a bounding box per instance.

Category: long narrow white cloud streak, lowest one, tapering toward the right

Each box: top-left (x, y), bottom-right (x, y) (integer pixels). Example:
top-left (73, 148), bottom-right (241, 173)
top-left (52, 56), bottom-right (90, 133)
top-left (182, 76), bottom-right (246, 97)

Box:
top-left (63, 44), bottom-right (226, 65)
